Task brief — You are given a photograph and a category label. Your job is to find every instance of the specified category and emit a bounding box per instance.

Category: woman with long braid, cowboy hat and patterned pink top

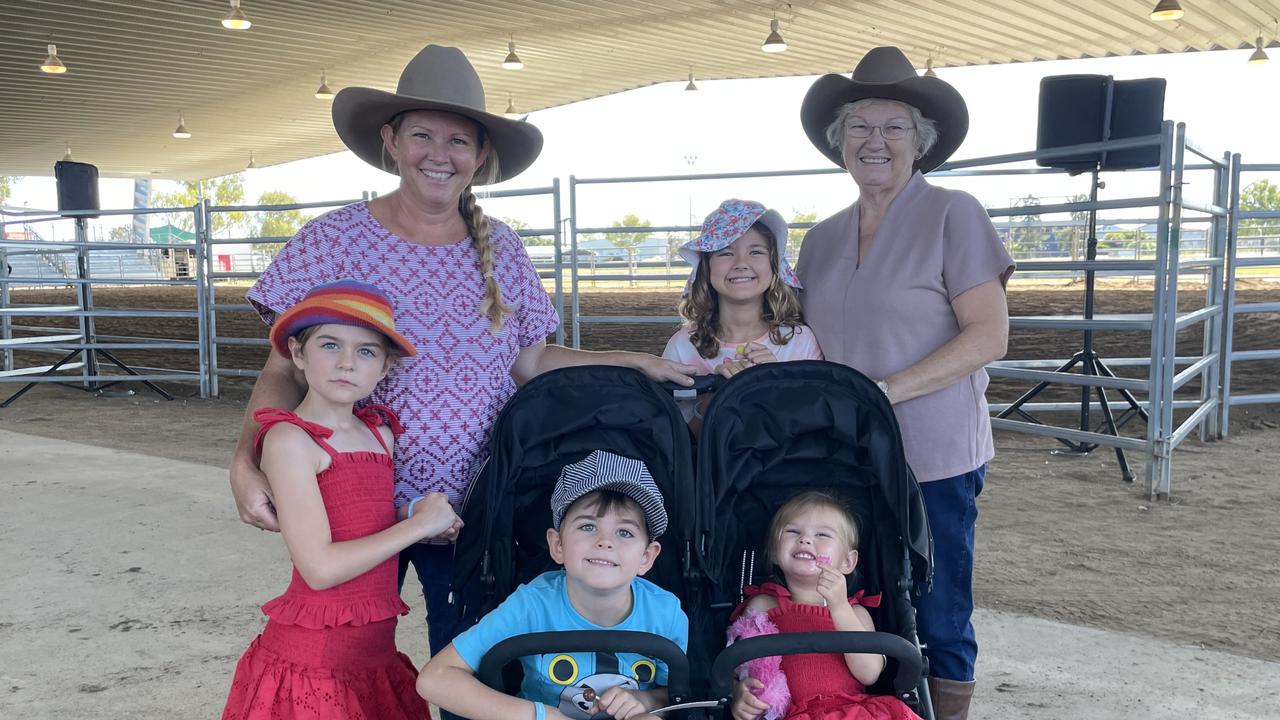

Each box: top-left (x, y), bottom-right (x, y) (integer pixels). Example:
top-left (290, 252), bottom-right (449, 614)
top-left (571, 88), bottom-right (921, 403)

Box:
top-left (230, 45), bottom-right (694, 653)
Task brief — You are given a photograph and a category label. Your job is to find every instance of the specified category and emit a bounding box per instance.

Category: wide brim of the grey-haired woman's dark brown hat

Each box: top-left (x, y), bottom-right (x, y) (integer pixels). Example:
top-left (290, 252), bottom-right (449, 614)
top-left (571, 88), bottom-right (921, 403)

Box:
top-left (800, 74), bottom-right (969, 173)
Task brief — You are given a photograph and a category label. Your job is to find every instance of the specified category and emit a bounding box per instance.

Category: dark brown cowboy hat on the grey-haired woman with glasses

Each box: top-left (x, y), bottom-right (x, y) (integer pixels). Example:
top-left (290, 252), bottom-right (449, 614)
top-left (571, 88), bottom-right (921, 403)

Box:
top-left (800, 47), bottom-right (969, 173)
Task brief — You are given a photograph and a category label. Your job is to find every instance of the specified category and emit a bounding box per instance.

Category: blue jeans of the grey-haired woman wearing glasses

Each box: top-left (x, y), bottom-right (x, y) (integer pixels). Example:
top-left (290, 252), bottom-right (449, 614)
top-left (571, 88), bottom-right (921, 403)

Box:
top-left (915, 465), bottom-right (987, 682)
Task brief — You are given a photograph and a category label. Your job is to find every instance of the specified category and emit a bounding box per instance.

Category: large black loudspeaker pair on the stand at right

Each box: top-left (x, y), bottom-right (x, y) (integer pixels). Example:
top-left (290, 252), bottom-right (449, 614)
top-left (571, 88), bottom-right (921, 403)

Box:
top-left (1036, 76), bottom-right (1165, 172)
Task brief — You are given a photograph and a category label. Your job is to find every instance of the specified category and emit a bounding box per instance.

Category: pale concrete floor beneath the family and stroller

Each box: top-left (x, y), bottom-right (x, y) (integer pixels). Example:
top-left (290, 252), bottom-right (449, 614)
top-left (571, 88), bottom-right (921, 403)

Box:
top-left (0, 430), bottom-right (1280, 720)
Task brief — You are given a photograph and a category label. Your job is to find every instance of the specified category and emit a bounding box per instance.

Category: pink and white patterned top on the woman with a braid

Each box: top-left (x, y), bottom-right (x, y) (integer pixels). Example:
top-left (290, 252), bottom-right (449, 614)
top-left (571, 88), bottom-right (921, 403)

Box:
top-left (247, 202), bottom-right (559, 507)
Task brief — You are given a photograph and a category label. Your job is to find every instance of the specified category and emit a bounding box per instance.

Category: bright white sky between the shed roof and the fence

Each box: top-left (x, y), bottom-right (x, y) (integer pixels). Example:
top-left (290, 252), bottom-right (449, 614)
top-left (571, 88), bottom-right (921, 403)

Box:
top-left (2, 44), bottom-right (1280, 240)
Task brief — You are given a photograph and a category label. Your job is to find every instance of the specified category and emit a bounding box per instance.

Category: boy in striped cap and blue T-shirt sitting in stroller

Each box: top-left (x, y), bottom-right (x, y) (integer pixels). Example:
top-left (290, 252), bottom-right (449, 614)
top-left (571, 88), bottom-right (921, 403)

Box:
top-left (417, 450), bottom-right (689, 720)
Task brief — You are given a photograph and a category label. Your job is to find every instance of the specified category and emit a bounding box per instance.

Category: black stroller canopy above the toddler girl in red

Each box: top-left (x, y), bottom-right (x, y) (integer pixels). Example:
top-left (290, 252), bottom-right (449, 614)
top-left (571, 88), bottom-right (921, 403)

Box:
top-left (696, 361), bottom-right (931, 592)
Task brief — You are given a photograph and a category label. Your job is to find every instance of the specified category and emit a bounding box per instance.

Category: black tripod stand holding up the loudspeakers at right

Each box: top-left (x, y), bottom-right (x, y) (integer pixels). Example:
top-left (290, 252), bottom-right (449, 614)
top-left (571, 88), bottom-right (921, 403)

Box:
top-left (997, 167), bottom-right (1149, 483)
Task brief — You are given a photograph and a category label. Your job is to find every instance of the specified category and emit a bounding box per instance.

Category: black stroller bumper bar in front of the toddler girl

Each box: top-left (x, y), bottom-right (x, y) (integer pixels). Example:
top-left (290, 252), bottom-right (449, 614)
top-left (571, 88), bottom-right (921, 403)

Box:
top-left (710, 632), bottom-right (922, 701)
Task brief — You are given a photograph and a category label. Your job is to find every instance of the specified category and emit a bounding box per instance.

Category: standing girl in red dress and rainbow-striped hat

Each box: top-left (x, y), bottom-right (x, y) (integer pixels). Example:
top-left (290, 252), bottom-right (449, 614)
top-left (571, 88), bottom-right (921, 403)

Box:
top-left (223, 279), bottom-right (462, 720)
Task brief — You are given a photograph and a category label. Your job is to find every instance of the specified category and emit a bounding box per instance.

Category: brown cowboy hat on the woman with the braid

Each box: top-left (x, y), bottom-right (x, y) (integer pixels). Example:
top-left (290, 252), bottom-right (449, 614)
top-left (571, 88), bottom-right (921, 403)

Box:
top-left (333, 45), bottom-right (543, 182)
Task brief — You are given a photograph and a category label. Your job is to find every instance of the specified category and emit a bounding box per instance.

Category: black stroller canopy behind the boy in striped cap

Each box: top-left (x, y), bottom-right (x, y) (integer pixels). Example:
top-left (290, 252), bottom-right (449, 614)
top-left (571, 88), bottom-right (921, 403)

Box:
top-left (453, 365), bottom-right (692, 600)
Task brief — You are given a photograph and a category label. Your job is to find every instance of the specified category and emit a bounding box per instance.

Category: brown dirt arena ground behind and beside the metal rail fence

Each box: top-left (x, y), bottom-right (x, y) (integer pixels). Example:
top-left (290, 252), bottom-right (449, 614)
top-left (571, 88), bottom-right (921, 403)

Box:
top-left (0, 284), bottom-right (1280, 707)
